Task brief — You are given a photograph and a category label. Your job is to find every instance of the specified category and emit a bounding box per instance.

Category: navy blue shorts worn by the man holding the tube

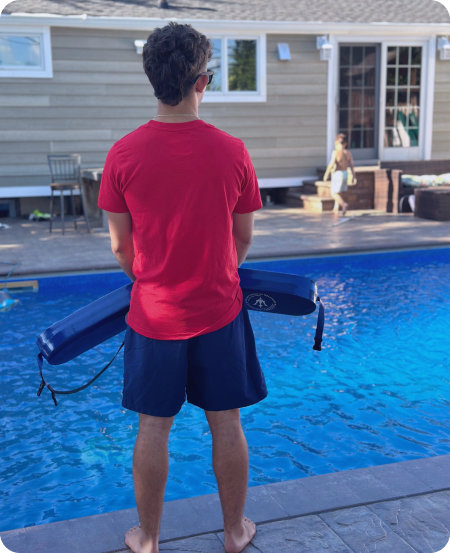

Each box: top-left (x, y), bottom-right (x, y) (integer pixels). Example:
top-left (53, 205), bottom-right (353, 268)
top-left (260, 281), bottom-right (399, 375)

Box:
top-left (122, 306), bottom-right (267, 417)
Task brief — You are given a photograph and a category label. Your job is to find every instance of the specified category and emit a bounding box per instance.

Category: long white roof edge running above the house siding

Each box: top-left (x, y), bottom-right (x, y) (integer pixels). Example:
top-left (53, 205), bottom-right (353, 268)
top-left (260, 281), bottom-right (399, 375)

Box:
top-left (0, 13), bottom-right (450, 36)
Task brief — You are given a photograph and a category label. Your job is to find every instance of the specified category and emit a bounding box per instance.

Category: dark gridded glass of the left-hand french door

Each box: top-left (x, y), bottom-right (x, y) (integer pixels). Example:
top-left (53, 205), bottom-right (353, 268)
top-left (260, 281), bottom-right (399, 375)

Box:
top-left (339, 46), bottom-right (378, 151)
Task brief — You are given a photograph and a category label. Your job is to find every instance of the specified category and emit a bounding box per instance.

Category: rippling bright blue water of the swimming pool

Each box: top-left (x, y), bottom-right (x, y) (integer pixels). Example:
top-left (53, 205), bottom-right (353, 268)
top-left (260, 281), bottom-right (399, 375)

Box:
top-left (0, 249), bottom-right (450, 530)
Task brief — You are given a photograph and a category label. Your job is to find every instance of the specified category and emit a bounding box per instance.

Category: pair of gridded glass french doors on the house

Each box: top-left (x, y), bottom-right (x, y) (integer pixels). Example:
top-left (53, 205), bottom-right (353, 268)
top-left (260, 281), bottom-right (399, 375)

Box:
top-left (335, 40), bottom-right (427, 161)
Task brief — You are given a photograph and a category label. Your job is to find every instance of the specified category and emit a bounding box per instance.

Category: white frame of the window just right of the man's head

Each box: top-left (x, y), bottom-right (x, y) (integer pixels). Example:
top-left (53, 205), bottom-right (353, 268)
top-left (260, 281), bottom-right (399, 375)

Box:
top-left (203, 33), bottom-right (267, 103)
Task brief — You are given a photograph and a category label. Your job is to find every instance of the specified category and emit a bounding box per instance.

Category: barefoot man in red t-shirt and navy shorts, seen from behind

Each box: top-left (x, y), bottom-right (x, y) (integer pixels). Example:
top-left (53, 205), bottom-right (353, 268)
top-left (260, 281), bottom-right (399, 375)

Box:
top-left (99, 23), bottom-right (267, 553)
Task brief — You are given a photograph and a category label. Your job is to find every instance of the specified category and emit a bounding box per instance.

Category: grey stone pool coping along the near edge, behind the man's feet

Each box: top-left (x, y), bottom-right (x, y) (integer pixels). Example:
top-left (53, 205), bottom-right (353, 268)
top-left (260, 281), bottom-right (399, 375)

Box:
top-left (0, 454), bottom-right (450, 553)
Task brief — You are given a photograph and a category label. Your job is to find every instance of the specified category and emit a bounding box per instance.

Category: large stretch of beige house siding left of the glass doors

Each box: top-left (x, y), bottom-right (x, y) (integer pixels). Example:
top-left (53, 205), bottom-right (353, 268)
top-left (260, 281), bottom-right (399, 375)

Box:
top-left (0, 28), bottom-right (327, 192)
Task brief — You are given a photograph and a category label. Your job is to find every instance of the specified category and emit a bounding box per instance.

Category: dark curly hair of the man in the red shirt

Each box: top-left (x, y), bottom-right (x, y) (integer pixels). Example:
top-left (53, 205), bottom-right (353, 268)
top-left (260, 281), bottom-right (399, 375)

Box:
top-left (143, 22), bottom-right (212, 106)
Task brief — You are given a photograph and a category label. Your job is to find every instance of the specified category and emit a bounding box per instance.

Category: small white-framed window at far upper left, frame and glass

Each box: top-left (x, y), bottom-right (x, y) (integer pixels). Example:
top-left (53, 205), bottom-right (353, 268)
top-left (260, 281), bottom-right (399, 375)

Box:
top-left (0, 28), bottom-right (53, 78)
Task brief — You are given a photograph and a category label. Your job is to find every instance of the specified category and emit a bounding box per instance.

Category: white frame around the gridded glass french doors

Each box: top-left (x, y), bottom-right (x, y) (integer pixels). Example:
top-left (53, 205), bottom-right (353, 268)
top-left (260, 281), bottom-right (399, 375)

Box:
top-left (327, 35), bottom-right (436, 161)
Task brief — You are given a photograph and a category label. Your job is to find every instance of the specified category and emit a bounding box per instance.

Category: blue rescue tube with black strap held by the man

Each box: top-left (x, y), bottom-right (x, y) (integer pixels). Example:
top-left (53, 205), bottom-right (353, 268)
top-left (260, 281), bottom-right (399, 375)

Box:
top-left (36, 269), bottom-right (325, 405)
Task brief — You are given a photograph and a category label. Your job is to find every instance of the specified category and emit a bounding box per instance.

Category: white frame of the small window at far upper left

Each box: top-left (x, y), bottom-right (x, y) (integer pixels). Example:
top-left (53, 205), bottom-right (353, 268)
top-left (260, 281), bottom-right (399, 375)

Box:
top-left (0, 26), bottom-right (53, 79)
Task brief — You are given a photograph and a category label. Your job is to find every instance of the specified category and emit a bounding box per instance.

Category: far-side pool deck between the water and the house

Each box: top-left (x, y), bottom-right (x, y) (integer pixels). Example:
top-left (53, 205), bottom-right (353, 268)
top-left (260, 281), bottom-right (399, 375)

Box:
top-left (0, 206), bottom-right (450, 275)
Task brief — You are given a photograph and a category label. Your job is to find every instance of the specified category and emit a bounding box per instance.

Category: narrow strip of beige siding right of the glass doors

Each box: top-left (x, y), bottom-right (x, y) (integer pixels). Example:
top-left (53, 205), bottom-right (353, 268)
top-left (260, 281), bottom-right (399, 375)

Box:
top-left (432, 58), bottom-right (450, 159)
